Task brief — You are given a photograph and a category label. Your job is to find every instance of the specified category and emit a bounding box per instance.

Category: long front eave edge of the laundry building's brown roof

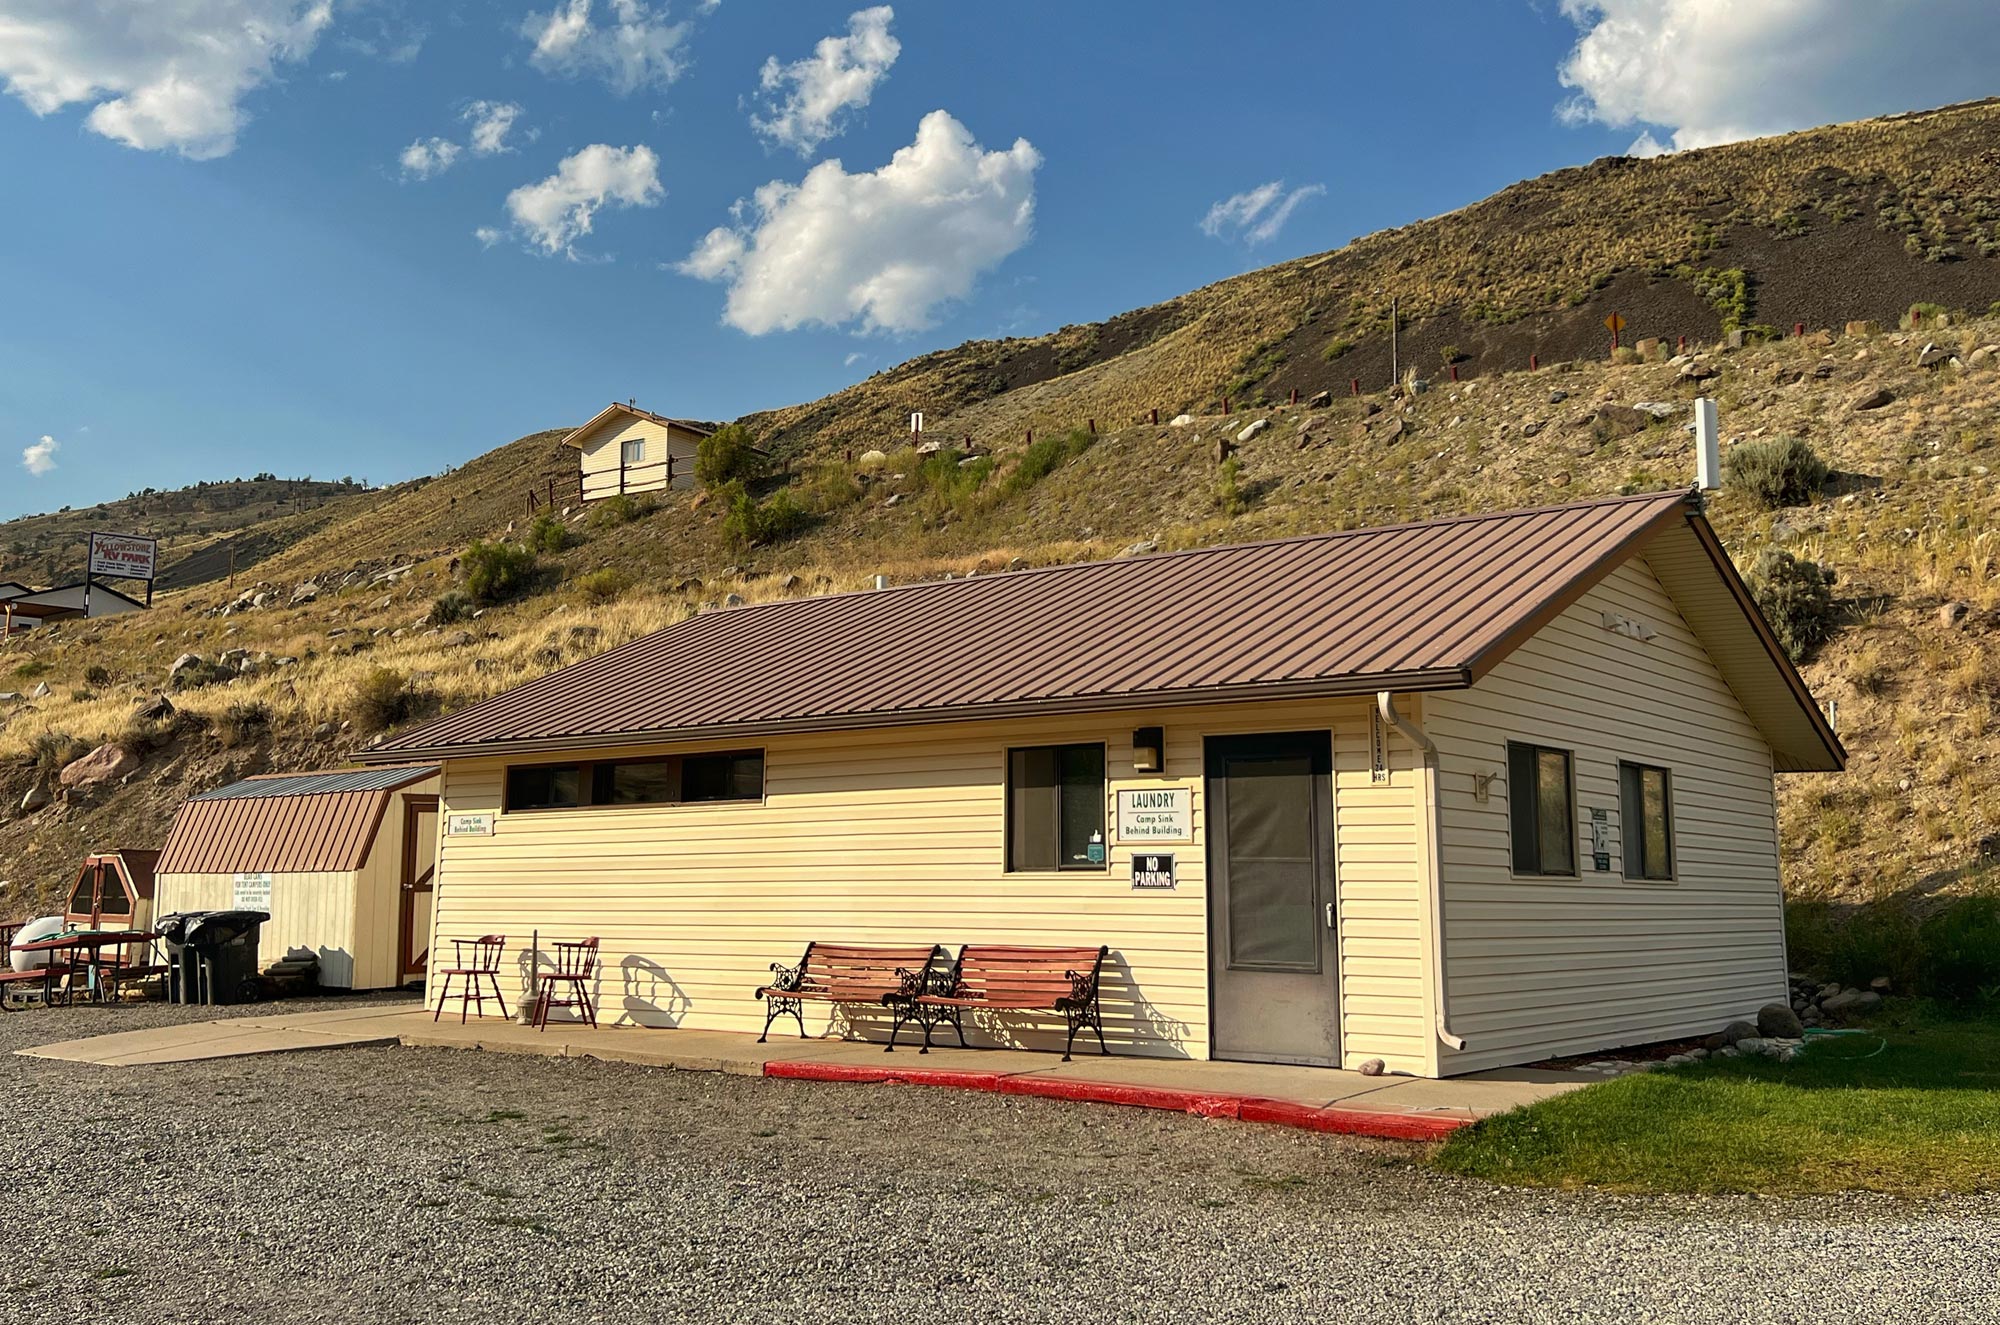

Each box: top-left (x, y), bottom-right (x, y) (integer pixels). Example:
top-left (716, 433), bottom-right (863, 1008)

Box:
top-left (352, 667), bottom-right (1472, 765)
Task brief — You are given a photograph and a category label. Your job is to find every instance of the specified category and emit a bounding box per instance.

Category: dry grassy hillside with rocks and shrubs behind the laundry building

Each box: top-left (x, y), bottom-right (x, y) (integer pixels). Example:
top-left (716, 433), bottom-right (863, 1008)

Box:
top-left (0, 106), bottom-right (2000, 932)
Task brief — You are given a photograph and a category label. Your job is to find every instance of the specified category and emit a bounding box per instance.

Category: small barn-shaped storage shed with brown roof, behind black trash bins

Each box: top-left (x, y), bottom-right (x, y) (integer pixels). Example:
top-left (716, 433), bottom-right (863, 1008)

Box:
top-left (154, 765), bottom-right (438, 989)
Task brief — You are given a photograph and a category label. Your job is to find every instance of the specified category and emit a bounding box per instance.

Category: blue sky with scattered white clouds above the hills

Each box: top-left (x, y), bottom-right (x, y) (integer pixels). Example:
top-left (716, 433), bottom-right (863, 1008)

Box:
top-left (0, 0), bottom-right (2000, 518)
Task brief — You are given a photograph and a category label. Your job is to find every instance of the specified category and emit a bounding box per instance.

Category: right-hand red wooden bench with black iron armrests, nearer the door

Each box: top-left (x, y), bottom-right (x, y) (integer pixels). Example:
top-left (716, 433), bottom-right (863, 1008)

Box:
top-left (890, 943), bottom-right (1110, 1063)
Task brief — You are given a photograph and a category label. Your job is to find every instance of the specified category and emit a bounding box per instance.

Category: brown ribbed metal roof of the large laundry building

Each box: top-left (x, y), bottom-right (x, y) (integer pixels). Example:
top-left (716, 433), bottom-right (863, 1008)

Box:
top-left (358, 492), bottom-right (1840, 767)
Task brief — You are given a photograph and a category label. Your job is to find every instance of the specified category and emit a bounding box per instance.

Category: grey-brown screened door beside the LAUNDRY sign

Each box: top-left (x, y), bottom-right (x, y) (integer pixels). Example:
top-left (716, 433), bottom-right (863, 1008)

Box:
top-left (1206, 731), bottom-right (1340, 1067)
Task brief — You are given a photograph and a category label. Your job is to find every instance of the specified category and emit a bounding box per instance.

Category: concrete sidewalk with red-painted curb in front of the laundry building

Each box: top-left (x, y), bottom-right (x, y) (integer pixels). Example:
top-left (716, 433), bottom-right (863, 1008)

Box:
top-left (18, 1007), bottom-right (1590, 1139)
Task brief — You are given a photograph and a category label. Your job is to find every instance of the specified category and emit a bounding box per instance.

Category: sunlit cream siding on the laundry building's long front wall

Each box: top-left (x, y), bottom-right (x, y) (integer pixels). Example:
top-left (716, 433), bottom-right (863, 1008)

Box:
top-left (432, 701), bottom-right (1424, 1069)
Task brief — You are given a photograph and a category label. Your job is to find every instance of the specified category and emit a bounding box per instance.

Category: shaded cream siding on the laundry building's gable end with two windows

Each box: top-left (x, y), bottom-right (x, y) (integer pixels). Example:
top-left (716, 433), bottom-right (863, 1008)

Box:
top-left (1426, 560), bottom-right (1786, 1073)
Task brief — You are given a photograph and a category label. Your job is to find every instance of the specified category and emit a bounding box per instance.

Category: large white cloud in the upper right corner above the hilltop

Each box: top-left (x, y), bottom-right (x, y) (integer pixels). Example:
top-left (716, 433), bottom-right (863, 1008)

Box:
top-left (1562, 0), bottom-right (2000, 154)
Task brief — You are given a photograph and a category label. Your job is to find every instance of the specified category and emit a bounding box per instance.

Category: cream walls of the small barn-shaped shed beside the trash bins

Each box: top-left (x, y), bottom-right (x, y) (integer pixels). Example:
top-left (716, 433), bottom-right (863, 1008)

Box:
top-left (154, 779), bottom-right (438, 989)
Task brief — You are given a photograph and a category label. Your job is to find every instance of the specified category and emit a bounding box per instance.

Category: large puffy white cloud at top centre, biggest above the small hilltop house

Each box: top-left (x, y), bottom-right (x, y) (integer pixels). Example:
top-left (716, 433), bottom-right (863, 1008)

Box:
top-left (678, 110), bottom-right (1042, 336)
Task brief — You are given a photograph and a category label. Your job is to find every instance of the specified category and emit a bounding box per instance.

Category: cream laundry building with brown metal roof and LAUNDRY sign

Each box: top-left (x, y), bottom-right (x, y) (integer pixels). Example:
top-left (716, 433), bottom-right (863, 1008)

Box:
top-left (362, 492), bottom-right (1846, 1077)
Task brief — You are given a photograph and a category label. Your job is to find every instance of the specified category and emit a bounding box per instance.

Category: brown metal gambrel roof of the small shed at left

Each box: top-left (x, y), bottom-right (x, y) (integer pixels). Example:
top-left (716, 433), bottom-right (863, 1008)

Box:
top-left (158, 765), bottom-right (438, 875)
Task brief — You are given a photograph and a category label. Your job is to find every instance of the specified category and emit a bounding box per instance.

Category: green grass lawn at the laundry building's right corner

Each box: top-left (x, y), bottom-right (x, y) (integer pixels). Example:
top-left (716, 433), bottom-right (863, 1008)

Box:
top-left (1434, 1009), bottom-right (2000, 1197)
